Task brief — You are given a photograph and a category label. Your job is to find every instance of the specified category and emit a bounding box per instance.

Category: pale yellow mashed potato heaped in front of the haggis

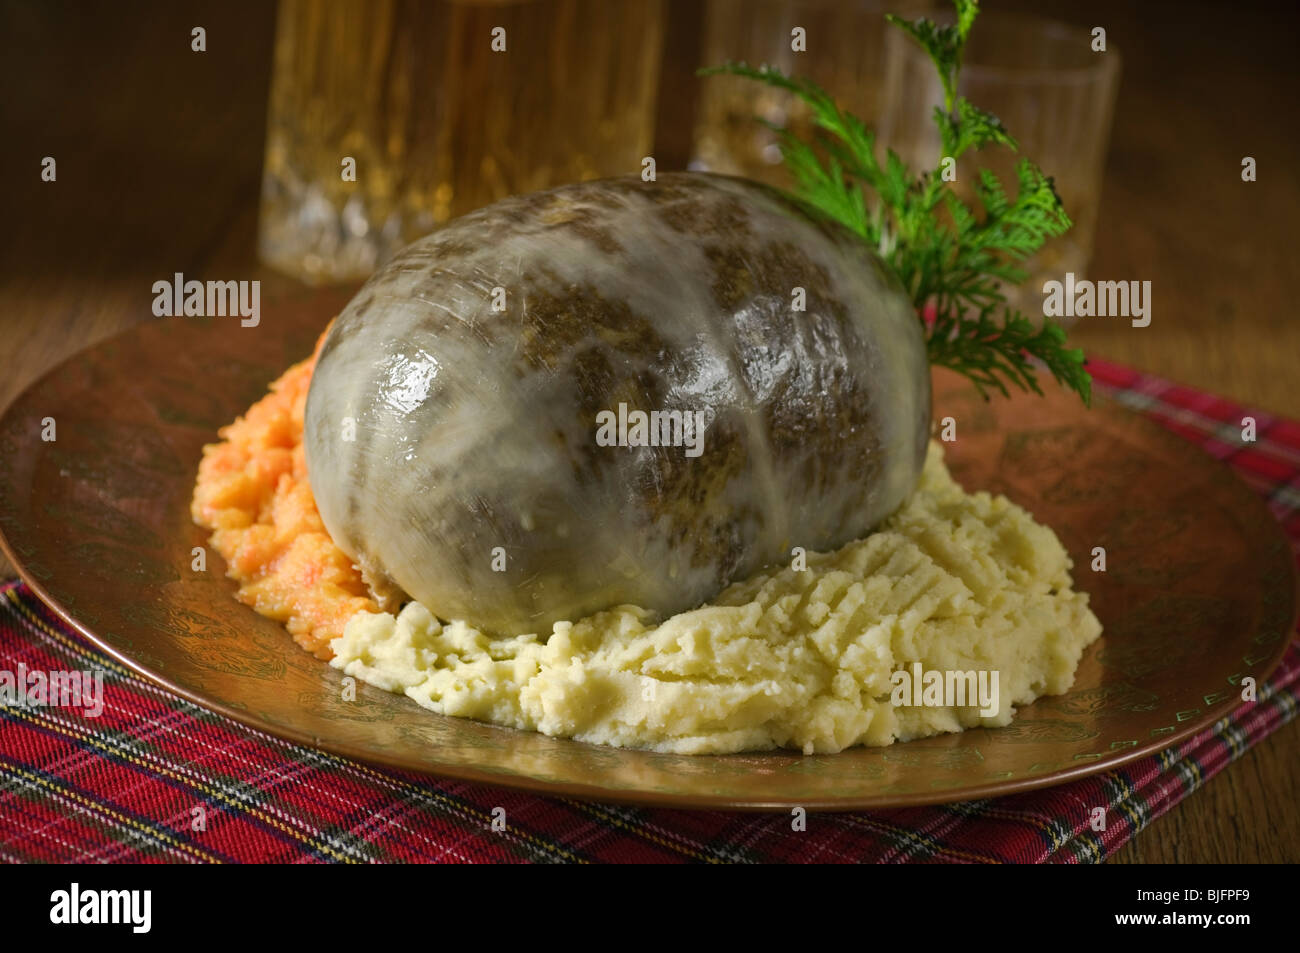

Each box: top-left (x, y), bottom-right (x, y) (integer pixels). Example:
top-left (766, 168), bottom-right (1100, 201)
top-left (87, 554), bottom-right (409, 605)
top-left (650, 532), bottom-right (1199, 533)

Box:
top-left (330, 443), bottom-right (1101, 754)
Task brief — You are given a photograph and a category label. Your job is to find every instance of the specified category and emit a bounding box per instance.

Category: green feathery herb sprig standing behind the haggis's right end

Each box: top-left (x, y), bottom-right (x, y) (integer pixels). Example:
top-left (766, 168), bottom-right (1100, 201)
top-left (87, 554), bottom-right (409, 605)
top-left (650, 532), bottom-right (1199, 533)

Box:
top-left (701, 0), bottom-right (1092, 404)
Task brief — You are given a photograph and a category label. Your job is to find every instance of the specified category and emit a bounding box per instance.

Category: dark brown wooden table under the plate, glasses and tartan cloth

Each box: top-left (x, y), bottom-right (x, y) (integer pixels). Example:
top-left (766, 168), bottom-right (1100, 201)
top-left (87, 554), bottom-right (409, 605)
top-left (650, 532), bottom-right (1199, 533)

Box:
top-left (0, 0), bottom-right (1300, 863)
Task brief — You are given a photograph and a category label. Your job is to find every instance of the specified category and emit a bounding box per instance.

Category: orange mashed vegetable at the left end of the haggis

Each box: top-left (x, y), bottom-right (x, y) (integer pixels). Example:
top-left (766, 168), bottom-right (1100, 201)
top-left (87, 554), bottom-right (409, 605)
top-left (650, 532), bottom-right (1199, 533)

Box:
top-left (190, 335), bottom-right (380, 659)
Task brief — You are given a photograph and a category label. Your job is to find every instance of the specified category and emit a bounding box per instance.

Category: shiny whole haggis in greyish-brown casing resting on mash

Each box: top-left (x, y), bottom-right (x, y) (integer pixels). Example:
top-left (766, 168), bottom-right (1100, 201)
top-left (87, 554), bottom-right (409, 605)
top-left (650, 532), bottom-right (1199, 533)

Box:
top-left (307, 173), bottom-right (930, 632)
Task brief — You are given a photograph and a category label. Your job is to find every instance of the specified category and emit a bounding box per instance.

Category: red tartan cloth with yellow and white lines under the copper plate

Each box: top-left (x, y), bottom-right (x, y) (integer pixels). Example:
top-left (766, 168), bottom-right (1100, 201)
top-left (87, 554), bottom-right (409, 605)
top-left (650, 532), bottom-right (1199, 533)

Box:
top-left (0, 360), bottom-right (1300, 863)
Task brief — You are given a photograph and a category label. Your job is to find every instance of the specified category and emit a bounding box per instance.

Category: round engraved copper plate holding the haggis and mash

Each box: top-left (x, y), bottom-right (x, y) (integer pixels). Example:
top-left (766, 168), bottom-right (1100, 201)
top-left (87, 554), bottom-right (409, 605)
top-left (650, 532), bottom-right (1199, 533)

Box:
top-left (0, 295), bottom-right (1296, 810)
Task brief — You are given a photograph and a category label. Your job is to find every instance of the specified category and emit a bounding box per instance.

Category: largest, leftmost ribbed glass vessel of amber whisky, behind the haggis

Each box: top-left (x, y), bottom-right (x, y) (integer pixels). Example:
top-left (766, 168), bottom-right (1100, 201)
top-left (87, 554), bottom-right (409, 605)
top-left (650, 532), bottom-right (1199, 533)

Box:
top-left (259, 0), bottom-right (663, 282)
